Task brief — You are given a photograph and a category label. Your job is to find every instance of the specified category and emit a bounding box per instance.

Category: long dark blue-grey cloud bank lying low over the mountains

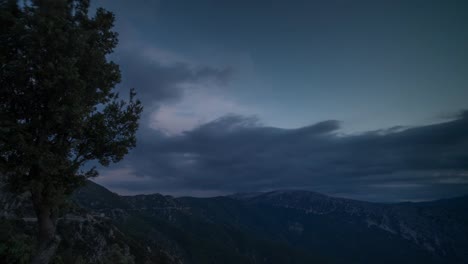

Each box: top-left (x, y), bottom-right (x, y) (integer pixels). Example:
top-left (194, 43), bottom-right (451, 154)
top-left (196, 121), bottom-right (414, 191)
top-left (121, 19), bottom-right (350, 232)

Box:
top-left (98, 112), bottom-right (468, 200)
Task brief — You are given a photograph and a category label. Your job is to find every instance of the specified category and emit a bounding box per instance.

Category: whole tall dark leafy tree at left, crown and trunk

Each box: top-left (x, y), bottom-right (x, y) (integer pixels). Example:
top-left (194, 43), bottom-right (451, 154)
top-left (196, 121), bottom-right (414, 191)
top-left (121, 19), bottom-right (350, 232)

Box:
top-left (0, 0), bottom-right (142, 263)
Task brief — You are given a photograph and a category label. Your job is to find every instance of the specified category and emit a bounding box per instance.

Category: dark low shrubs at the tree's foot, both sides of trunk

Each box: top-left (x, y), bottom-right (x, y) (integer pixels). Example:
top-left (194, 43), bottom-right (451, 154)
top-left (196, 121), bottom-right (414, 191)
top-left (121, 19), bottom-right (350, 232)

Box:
top-left (0, 219), bottom-right (139, 264)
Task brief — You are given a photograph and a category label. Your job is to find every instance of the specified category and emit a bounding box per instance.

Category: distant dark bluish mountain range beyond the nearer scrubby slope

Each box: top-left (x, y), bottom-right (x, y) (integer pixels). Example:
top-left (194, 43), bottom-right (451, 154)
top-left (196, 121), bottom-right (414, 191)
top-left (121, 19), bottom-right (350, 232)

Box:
top-left (75, 184), bottom-right (468, 263)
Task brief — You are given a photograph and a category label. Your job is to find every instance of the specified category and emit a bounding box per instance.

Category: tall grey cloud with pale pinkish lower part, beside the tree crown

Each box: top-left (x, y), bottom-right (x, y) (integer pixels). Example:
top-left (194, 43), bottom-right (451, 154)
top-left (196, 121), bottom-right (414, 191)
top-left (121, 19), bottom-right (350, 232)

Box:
top-left (96, 0), bottom-right (260, 136)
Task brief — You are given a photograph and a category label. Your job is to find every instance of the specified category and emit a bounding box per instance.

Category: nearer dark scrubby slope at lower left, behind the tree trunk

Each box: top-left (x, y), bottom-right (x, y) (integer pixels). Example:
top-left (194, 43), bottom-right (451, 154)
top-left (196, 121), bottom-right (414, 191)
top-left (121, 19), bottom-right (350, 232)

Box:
top-left (0, 181), bottom-right (181, 264)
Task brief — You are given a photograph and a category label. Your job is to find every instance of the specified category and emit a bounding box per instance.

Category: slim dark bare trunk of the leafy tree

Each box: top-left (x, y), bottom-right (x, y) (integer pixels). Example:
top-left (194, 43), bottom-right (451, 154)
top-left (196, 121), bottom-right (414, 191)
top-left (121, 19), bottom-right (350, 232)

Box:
top-left (31, 193), bottom-right (60, 264)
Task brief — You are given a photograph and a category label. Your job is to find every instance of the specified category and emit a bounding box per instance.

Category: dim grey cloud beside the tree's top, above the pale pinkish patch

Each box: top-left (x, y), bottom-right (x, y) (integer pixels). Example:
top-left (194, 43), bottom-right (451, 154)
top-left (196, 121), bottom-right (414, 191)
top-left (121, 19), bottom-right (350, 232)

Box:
top-left (92, 0), bottom-right (232, 105)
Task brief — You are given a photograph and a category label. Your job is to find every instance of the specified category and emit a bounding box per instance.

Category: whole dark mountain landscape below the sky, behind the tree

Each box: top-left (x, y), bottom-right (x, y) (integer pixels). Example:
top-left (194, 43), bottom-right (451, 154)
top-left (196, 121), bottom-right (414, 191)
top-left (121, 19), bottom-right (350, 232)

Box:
top-left (0, 182), bottom-right (468, 264)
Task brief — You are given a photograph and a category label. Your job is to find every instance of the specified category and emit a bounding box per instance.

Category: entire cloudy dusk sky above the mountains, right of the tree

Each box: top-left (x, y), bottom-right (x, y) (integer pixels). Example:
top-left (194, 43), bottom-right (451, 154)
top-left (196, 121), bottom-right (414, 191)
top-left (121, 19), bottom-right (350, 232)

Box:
top-left (92, 0), bottom-right (468, 202)
